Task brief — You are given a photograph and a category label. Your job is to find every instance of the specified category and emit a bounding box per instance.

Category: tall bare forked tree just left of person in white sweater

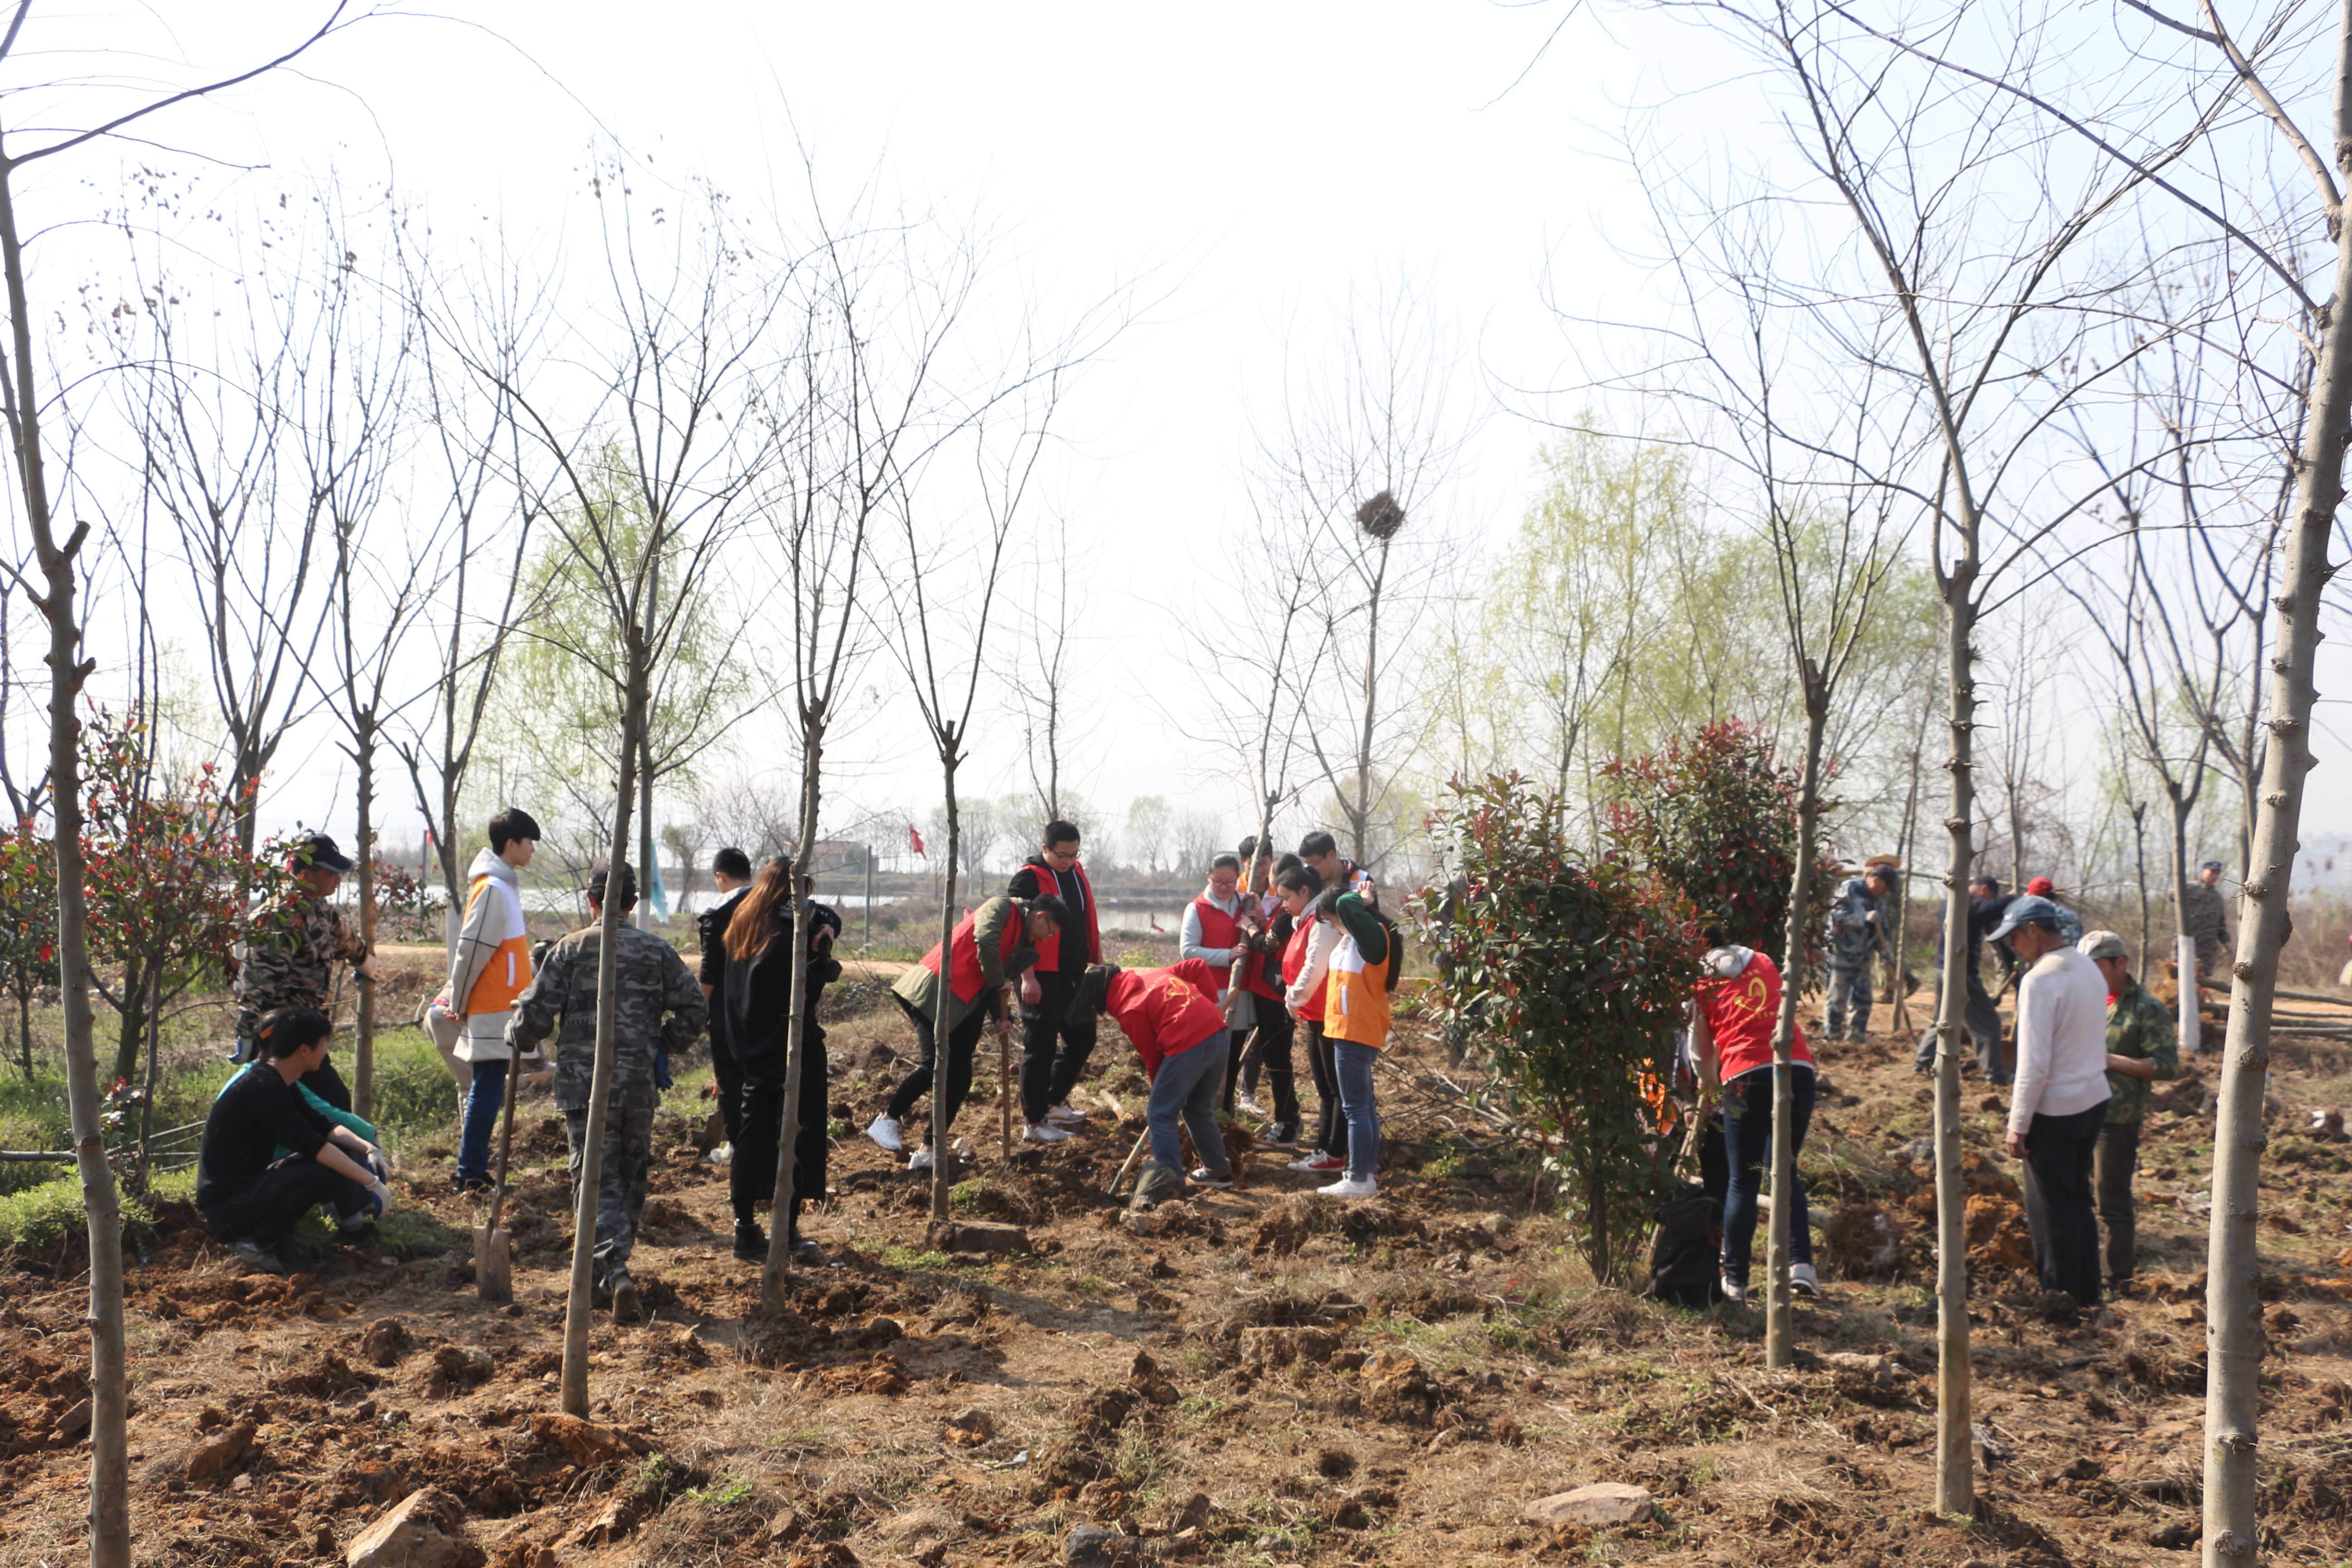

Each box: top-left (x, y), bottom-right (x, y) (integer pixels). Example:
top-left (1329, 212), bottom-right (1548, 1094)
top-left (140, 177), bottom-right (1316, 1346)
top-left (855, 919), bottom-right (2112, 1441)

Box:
top-left (1646, 0), bottom-right (2192, 1514)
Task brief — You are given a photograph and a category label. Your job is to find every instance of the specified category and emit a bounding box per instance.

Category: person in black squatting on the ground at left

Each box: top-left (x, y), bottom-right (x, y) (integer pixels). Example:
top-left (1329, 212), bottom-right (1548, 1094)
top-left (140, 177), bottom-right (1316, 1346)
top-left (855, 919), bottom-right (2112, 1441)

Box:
top-left (195, 1006), bottom-right (393, 1274)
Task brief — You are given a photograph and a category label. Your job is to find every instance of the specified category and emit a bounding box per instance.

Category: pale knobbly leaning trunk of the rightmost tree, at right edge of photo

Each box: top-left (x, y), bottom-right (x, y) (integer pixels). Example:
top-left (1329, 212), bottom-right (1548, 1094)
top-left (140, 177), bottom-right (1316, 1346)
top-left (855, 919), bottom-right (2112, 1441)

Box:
top-left (2204, 34), bottom-right (2352, 1542)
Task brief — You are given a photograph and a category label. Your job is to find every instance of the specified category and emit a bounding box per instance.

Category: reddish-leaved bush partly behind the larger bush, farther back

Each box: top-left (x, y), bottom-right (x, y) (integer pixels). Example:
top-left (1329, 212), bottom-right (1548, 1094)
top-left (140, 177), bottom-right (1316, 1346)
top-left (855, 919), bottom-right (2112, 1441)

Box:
top-left (1602, 720), bottom-right (1837, 992)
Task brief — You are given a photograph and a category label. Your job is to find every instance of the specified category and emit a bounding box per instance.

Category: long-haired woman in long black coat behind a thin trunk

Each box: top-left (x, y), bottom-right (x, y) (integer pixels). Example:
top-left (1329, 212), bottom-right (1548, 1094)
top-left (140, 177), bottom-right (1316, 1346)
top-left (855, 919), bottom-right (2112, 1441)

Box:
top-left (734, 856), bottom-right (842, 1262)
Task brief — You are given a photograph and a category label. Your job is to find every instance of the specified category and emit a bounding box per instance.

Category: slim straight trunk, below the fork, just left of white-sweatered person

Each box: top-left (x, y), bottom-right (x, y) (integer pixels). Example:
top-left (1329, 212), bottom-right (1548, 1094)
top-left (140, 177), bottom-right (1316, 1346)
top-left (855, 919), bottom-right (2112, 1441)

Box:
top-left (1936, 580), bottom-right (1976, 1516)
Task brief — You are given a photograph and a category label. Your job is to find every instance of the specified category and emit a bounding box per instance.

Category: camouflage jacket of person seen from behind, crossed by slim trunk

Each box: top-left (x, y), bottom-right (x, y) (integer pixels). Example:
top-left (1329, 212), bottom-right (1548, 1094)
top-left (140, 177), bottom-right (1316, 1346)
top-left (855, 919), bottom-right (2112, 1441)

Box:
top-left (506, 921), bottom-right (710, 1110)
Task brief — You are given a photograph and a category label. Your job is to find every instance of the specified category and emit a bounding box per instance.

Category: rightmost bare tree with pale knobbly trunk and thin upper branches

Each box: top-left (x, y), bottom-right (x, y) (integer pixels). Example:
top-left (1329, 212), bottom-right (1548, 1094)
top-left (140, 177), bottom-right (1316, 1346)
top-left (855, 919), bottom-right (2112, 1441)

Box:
top-left (1787, 0), bottom-right (2352, 1542)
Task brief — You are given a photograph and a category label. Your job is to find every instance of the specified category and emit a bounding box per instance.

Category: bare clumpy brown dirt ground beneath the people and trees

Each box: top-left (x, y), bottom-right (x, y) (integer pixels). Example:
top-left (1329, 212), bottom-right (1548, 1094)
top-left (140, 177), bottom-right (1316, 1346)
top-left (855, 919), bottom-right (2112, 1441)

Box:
top-left (0, 978), bottom-right (2352, 1568)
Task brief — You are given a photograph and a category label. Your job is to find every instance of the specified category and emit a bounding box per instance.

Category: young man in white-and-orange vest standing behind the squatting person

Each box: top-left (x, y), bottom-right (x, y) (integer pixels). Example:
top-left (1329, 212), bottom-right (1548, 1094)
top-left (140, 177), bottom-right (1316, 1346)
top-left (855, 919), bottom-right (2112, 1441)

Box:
top-left (442, 806), bottom-right (539, 1192)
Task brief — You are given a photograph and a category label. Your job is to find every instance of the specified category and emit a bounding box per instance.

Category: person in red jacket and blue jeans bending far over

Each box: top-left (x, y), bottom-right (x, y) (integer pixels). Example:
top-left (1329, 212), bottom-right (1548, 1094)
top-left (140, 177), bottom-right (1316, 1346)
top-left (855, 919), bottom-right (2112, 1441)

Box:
top-left (1068, 959), bottom-right (1232, 1187)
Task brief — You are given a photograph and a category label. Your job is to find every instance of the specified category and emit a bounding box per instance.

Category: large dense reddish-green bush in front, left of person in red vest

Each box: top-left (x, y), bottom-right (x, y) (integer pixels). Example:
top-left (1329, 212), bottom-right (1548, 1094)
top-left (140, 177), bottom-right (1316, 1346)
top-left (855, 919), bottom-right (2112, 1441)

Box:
top-left (1430, 774), bottom-right (1698, 1284)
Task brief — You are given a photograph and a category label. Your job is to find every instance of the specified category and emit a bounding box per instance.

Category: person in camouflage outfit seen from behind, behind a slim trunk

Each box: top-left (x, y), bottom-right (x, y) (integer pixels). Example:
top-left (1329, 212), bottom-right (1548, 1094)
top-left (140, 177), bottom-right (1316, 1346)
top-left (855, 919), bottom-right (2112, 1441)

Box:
top-left (506, 863), bottom-right (710, 1323)
